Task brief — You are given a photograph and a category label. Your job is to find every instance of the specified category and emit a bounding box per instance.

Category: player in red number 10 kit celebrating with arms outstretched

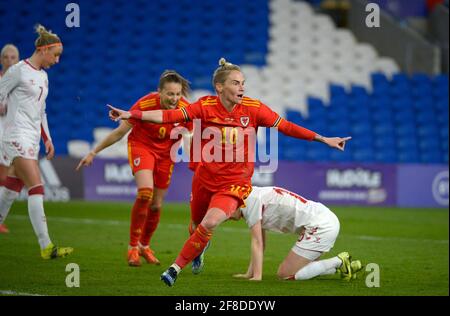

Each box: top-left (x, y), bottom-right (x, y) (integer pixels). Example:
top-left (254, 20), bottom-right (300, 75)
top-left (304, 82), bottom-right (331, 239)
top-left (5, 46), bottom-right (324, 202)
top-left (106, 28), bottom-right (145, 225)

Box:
top-left (109, 58), bottom-right (350, 286)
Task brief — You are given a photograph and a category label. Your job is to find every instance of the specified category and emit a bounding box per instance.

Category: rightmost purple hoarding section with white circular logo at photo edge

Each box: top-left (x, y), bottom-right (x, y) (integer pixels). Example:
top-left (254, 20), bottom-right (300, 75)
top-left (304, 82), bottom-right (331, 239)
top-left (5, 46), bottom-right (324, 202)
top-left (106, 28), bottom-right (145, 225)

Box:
top-left (397, 165), bottom-right (448, 207)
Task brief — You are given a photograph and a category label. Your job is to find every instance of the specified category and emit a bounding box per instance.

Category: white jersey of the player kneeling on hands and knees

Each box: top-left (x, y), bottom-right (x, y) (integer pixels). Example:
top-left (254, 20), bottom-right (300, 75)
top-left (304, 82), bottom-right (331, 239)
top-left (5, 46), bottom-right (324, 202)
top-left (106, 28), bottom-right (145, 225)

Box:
top-left (241, 187), bottom-right (331, 234)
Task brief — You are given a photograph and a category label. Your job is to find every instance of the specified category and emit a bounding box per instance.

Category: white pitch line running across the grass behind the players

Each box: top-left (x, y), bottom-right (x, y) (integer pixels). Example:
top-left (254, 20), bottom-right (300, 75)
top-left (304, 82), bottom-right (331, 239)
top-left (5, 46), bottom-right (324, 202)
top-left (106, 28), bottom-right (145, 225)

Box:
top-left (8, 215), bottom-right (448, 244)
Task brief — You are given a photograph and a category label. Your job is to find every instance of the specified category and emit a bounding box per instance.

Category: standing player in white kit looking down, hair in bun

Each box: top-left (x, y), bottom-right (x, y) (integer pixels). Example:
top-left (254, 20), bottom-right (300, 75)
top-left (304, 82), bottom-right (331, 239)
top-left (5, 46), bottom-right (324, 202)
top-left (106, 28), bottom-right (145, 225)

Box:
top-left (0, 25), bottom-right (73, 259)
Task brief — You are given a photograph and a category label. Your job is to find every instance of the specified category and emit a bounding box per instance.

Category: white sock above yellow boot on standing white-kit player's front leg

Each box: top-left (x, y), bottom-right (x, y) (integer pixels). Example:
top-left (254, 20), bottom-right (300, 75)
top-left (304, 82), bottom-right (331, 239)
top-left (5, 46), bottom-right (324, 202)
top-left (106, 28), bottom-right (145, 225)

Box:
top-left (28, 194), bottom-right (51, 249)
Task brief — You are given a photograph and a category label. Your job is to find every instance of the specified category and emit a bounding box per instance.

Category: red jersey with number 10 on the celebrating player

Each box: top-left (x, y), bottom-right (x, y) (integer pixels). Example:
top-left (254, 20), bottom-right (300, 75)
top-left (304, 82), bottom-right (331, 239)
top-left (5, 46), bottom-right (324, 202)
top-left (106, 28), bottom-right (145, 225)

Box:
top-left (181, 96), bottom-right (282, 188)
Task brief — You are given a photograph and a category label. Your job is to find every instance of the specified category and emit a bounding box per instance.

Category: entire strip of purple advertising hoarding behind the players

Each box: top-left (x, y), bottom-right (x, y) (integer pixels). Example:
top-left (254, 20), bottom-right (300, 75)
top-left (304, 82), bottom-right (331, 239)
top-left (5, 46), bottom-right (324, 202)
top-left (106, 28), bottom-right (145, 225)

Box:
top-left (84, 159), bottom-right (448, 207)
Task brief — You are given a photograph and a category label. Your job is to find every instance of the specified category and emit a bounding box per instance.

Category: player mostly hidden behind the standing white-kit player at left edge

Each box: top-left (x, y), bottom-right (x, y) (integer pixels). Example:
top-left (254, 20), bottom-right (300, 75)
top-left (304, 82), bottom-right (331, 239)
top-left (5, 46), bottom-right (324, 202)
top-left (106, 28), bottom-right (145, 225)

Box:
top-left (0, 44), bottom-right (19, 234)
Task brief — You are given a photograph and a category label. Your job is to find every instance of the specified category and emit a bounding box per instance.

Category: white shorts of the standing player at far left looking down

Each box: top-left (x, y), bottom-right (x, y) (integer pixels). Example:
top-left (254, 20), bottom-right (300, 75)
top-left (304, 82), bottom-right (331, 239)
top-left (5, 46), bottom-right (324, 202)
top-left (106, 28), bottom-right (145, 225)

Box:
top-left (0, 139), bottom-right (39, 166)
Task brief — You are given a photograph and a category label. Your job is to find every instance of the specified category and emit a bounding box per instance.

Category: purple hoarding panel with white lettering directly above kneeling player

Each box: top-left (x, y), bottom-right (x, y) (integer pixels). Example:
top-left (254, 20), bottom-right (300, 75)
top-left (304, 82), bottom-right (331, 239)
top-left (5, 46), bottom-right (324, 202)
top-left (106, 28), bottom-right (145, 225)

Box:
top-left (275, 162), bottom-right (396, 205)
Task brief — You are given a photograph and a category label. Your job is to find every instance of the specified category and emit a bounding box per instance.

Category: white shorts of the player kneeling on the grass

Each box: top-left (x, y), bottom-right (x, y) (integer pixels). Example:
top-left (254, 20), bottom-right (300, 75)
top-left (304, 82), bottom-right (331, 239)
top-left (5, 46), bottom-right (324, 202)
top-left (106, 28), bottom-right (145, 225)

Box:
top-left (292, 204), bottom-right (340, 261)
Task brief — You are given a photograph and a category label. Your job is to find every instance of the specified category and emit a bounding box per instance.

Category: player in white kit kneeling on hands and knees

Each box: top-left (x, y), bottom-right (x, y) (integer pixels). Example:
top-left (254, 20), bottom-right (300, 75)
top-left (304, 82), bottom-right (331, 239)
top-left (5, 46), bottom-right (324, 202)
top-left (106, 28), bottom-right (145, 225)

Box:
top-left (232, 187), bottom-right (362, 280)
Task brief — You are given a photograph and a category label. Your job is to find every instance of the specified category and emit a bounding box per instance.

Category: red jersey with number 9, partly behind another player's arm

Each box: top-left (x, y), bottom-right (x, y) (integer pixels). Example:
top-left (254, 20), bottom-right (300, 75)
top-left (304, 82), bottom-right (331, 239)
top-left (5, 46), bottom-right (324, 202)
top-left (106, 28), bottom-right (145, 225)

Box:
top-left (128, 92), bottom-right (192, 158)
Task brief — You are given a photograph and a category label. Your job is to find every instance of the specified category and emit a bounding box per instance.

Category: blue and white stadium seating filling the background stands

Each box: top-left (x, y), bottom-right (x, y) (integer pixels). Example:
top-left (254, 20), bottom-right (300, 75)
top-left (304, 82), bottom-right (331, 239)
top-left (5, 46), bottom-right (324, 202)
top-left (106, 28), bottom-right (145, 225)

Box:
top-left (0, 0), bottom-right (449, 163)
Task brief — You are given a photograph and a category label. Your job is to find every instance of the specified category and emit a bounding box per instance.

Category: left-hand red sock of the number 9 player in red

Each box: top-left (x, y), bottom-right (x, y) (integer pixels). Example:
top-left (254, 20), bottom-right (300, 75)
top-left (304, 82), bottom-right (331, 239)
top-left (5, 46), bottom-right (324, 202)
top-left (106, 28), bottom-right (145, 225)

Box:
top-left (130, 188), bottom-right (153, 247)
